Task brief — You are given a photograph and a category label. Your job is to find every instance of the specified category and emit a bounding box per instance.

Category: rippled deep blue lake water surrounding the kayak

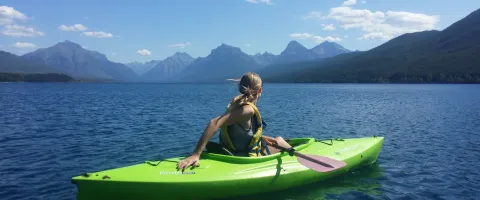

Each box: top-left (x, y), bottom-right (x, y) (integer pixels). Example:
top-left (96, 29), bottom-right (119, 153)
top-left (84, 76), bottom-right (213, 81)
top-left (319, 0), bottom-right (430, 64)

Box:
top-left (0, 83), bottom-right (480, 200)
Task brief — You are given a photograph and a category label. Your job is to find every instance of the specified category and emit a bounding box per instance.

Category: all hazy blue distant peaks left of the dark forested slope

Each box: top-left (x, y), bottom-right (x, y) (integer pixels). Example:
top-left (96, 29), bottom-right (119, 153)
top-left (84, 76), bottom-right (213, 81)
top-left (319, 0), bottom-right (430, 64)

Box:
top-left (0, 37), bottom-right (349, 82)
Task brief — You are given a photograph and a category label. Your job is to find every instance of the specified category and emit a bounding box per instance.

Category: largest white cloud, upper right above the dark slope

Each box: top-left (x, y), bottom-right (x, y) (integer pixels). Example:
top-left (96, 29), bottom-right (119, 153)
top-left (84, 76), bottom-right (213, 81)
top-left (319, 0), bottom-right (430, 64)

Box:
top-left (327, 7), bottom-right (439, 40)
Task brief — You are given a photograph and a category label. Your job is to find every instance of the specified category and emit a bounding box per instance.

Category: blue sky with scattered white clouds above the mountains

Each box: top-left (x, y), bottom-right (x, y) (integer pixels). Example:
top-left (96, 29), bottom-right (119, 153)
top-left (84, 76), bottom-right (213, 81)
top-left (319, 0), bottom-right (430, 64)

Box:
top-left (0, 0), bottom-right (480, 63)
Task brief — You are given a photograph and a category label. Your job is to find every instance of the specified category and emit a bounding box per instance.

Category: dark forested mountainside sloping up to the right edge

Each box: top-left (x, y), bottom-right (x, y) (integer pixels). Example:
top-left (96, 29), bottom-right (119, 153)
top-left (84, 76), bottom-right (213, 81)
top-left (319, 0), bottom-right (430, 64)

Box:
top-left (263, 7), bottom-right (480, 83)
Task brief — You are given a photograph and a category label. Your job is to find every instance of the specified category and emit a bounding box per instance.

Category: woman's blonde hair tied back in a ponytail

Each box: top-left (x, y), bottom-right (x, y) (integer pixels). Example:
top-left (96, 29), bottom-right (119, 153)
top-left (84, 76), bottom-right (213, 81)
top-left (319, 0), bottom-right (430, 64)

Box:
top-left (227, 72), bottom-right (263, 110)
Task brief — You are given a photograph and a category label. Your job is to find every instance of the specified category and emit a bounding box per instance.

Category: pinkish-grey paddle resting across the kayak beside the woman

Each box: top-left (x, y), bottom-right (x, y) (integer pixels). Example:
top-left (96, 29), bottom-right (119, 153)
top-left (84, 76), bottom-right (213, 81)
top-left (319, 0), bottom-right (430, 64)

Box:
top-left (269, 144), bottom-right (347, 172)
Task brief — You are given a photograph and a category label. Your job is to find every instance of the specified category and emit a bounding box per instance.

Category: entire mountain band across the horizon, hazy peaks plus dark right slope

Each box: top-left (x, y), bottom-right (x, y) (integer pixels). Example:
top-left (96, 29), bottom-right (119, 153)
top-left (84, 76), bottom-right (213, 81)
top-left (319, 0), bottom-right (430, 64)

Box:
top-left (0, 10), bottom-right (480, 83)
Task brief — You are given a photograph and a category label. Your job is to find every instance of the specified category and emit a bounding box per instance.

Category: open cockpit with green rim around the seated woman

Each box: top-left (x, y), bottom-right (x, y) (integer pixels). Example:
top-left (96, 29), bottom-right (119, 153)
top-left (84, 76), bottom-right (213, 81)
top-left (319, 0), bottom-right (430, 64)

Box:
top-left (201, 138), bottom-right (315, 163)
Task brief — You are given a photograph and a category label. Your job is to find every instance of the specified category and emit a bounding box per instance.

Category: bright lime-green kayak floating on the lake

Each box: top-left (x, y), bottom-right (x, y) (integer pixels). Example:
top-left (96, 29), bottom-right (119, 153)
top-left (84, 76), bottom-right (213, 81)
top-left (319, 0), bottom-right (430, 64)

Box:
top-left (72, 136), bottom-right (383, 200)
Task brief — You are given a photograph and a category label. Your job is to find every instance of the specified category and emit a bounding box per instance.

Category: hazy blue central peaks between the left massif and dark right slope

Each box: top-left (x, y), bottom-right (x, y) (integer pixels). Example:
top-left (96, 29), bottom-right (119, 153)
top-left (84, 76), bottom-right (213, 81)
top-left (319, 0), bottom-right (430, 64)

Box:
top-left (134, 41), bottom-right (350, 82)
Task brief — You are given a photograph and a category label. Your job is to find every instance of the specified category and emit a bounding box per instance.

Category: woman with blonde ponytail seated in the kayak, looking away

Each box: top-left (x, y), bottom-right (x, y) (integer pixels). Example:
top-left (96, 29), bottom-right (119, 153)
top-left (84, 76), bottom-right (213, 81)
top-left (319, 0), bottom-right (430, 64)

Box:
top-left (177, 72), bottom-right (291, 170)
